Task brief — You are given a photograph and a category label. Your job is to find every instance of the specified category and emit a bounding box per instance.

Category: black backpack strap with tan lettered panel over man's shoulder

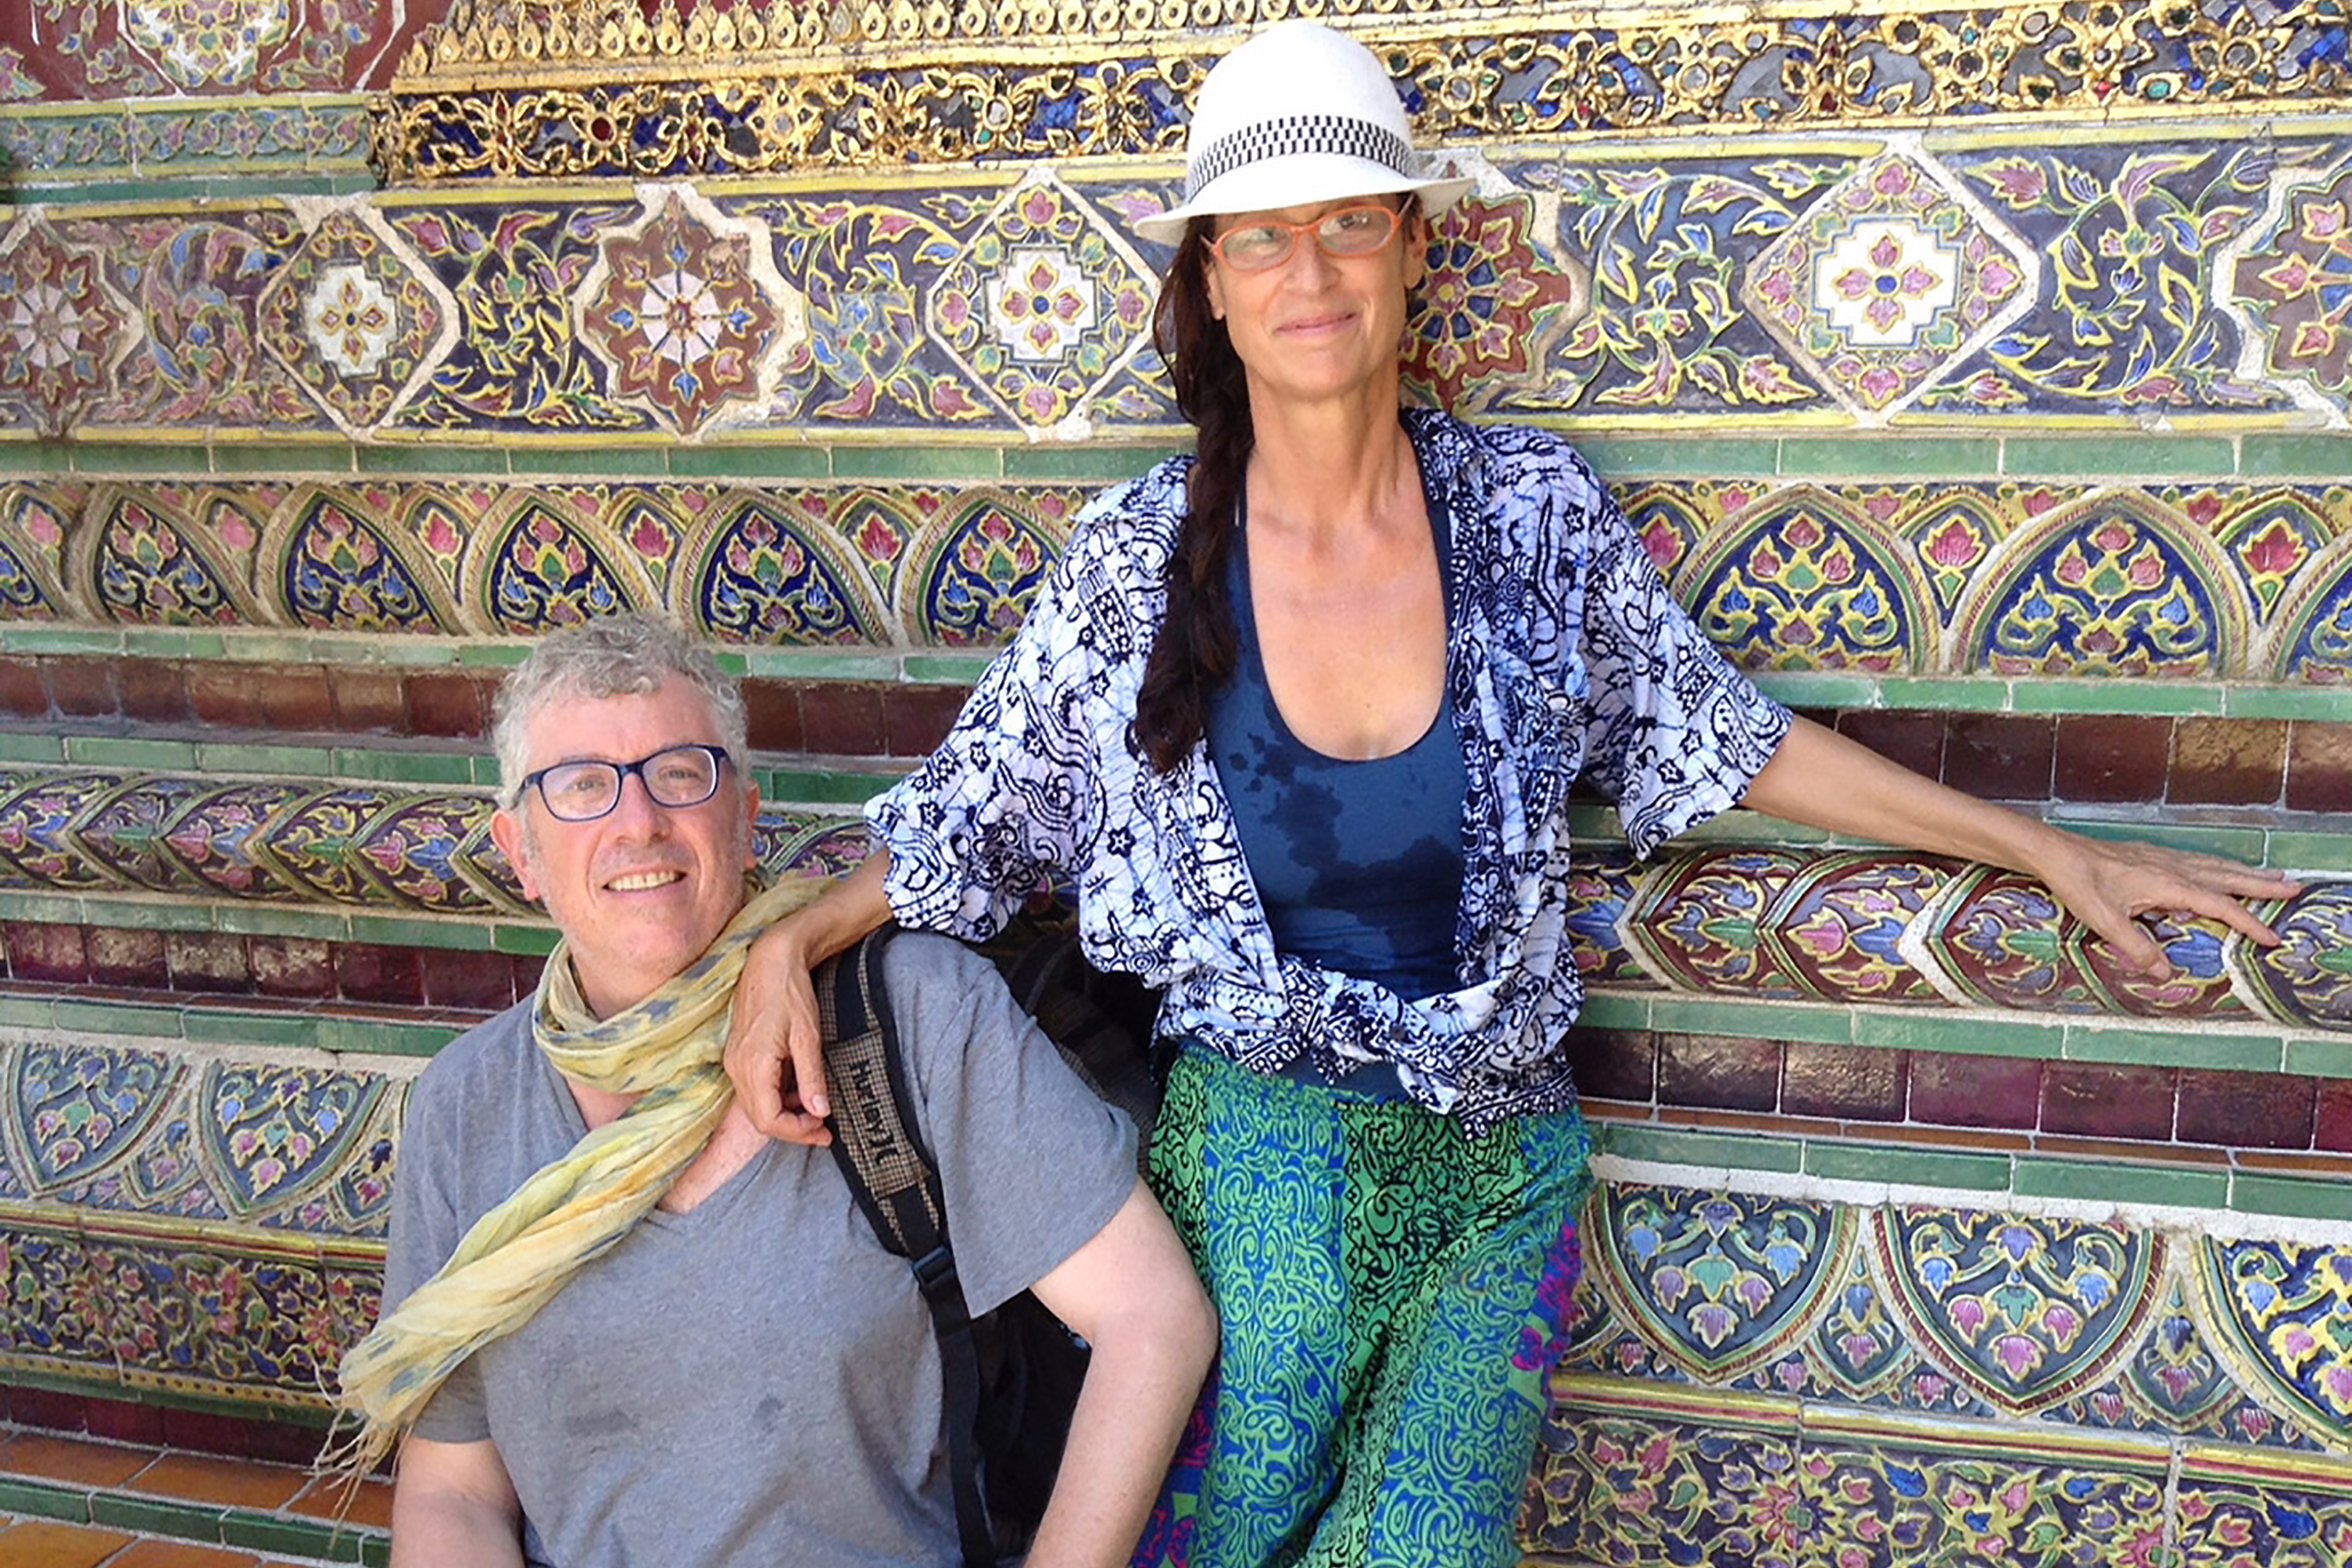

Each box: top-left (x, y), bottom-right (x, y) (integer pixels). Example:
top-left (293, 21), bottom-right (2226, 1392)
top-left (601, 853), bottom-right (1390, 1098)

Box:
top-left (811, 926), bottom-right (997, 1568)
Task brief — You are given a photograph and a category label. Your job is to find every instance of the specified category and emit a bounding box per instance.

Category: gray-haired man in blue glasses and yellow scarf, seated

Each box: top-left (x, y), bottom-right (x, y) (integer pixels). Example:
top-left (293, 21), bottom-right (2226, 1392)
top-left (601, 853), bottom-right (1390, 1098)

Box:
top-left (343, 616), bottom-right (1216, 1568)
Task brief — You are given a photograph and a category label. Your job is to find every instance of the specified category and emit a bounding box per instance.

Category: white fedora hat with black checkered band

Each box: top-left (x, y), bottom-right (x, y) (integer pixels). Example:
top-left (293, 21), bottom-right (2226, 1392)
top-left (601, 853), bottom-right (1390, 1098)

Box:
top-left (1136, 21), bottom-right (1477, 245)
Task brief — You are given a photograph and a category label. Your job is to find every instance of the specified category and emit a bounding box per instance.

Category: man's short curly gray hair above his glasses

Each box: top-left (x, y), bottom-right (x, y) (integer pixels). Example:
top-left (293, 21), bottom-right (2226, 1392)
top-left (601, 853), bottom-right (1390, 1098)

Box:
top-left (489, 609), bottom-right (748, 811)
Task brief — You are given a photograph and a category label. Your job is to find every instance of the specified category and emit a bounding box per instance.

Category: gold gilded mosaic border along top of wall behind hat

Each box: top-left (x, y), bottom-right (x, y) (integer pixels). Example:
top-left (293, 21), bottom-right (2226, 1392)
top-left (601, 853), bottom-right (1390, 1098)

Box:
top-left (374, 0), bottom-right (2352, 181)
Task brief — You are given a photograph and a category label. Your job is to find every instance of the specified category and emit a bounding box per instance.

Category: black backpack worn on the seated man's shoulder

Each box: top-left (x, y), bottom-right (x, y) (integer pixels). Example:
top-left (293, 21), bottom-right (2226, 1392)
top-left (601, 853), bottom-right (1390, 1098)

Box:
top-left (811, 922), bottom-right (1162, 1568)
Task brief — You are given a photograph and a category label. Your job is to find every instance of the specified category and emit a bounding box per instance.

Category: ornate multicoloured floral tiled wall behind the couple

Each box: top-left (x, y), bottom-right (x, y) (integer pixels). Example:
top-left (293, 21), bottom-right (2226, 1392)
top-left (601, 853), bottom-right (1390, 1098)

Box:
top-left (0, 0), bottom-right (2352, 1568)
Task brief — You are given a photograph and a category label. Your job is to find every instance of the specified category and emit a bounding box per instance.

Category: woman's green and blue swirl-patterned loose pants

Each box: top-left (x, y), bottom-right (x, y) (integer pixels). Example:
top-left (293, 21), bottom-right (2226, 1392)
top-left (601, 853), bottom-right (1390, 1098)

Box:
top-left (1136, 1051), bottom-right (1590, 1568)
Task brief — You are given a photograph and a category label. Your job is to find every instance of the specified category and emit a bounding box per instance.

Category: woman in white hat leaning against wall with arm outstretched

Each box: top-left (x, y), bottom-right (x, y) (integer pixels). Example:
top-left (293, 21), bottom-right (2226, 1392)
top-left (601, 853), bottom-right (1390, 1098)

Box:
top-left (727, 23), bottom-right (2293, 1566)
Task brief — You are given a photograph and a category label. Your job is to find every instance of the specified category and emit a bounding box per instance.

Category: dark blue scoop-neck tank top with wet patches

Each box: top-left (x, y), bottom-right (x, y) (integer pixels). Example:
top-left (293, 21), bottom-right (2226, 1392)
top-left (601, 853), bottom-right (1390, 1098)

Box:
top-left (1207, 499), bottom-right (1470, 1020)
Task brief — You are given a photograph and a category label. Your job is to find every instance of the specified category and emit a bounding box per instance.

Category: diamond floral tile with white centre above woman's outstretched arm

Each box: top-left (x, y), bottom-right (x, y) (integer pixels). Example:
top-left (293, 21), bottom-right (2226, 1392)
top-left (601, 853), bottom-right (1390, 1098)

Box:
top-left (1741, 152), bottom-right (2035, 418)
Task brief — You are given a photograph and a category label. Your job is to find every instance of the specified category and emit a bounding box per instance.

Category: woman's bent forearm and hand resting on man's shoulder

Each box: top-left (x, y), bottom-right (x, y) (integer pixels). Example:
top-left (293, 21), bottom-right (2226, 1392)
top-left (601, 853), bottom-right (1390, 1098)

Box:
top-left (722, 851), bottom-right (889, 1145)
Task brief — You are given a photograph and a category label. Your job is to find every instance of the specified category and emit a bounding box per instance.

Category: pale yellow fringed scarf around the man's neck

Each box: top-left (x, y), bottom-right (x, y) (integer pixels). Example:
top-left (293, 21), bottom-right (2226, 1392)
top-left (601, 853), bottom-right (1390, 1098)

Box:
top-left (322, 877), bottom-right (830, 1477)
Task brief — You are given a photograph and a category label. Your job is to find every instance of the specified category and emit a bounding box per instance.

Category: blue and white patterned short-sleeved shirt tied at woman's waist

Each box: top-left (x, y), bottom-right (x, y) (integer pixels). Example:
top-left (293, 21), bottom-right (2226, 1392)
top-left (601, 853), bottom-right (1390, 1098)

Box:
top-left (865, 411), bottom-right (1790, 1136)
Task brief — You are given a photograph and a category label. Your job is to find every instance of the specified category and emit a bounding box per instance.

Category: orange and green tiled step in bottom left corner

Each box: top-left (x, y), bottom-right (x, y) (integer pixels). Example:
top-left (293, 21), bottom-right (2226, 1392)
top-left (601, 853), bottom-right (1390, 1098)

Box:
top-left (0, 1427), bottom-right (393, 1568)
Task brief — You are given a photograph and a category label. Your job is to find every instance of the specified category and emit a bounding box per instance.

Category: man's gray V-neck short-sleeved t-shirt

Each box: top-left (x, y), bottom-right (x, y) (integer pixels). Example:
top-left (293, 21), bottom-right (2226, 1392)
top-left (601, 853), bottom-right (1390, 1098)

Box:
top-left (383, 933), bottom-right (1136, 1568)
